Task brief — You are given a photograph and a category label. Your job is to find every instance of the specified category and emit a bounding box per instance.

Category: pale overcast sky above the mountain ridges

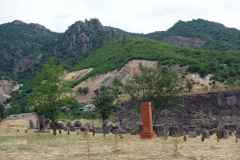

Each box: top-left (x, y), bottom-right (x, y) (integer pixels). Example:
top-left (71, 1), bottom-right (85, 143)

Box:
top-left (0, 0), bottom-right (240, 33)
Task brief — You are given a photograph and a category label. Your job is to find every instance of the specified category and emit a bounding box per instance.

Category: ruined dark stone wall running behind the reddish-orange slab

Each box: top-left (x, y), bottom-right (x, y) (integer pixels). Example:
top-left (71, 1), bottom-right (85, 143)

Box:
top-left (117, 90), bottom-right (240, 130)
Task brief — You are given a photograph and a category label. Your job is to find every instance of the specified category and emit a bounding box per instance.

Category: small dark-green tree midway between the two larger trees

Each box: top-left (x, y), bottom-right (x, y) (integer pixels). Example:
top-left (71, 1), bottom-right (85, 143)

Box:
top-left (93, 86), bottom-right (117, 121)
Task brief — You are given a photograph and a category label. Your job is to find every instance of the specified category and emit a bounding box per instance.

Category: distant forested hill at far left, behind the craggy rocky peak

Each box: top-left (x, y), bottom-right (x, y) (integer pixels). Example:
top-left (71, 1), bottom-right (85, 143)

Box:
top-left (0, 20), bottom-right (61, 78)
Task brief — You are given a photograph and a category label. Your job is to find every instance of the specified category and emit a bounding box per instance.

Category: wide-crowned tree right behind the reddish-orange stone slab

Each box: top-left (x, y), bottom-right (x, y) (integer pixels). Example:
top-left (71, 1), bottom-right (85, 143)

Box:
top-left (124, 63), bottom-right (183, 124)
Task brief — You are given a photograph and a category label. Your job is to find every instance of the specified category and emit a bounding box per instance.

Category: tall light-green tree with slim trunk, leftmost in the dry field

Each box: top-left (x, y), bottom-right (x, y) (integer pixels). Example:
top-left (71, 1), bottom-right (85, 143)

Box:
top-left (29, 57), bottom-right (72, 135)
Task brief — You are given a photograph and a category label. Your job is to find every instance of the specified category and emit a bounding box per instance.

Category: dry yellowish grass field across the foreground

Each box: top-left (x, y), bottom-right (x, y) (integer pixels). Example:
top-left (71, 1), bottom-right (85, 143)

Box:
top-left (0, 118), bottom-right (240, 160)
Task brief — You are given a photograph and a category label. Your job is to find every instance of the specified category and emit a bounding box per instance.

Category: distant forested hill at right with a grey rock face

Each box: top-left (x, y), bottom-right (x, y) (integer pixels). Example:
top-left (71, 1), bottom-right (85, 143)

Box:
top-left (107, 19), bottom-right (240, 51)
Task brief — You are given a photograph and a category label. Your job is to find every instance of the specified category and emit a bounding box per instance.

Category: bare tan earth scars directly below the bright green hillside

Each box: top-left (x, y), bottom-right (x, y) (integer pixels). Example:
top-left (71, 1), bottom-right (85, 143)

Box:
top-left (63, 60), bottom-right (212, 103)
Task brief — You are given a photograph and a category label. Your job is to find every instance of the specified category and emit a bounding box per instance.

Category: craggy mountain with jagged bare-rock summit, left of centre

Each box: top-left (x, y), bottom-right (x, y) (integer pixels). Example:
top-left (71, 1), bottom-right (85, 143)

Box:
top-left (15, 19), bottom-right (124, 78)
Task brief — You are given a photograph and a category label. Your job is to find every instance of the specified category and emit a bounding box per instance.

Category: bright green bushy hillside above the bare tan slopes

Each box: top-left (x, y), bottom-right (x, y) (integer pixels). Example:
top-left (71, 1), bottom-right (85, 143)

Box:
top-left (71, 37), bottom-right (240, 85)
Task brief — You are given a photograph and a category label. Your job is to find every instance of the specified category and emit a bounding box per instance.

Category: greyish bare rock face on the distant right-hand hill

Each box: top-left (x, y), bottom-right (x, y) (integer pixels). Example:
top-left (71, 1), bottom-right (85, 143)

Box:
top-left (163, 36), bottom-right (206, 49)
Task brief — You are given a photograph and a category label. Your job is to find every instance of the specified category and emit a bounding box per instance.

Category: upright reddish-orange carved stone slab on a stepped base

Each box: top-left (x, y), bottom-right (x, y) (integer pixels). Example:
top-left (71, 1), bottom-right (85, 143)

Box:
top-left (140, 102), bottom-right (156, 139)
